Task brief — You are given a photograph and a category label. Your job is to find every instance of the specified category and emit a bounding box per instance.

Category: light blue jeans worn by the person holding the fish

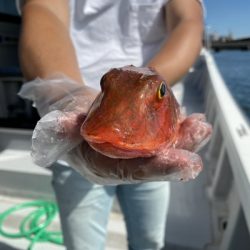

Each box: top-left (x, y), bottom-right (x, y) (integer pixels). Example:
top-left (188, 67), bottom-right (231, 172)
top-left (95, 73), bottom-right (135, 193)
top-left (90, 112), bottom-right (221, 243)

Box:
top-left (52, 164), bottom-right (169, 250)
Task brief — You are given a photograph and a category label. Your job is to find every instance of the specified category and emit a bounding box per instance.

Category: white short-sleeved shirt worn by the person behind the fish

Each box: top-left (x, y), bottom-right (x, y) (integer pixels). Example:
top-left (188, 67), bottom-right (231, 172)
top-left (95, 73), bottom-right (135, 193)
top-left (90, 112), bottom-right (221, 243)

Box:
top-left (17, 0), bottom-right (202, 89)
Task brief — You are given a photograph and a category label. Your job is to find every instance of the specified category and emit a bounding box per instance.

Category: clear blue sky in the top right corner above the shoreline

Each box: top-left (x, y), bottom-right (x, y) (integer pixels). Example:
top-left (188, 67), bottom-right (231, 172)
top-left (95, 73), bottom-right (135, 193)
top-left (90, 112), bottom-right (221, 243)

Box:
top-left (203, 0), bottom-right (250, 38)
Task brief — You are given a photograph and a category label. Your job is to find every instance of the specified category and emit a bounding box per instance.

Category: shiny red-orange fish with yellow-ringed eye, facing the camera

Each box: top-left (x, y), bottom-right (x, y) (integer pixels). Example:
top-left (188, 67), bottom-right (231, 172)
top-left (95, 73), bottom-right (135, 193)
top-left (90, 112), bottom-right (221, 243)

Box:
top-left (81, 66), bottom-right (211, 159)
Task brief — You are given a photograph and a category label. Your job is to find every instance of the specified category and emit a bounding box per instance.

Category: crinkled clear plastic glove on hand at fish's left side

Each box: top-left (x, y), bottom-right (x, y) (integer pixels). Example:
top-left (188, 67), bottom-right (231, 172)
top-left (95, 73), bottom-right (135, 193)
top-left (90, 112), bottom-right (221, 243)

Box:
top-left (19, 75), bottom-right (98, 167)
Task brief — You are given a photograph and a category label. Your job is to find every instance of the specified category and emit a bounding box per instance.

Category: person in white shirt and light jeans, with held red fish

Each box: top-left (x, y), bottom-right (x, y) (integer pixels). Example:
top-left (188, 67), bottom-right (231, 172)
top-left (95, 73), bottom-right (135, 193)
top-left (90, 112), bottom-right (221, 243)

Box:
top-left (17, 0), bottom-right (211, 250)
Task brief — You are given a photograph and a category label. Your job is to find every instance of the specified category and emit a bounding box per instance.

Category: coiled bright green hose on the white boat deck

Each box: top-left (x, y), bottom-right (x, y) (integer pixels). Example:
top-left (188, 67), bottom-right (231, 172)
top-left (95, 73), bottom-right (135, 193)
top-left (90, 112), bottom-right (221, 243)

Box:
top-left (0, 200), bottom-right (63, 250)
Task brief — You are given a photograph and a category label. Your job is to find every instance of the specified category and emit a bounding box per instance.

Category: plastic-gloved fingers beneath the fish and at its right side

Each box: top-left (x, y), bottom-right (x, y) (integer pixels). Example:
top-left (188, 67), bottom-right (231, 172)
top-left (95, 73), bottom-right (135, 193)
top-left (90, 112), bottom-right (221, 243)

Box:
top-left (68, 114), bottom-right (212, 185)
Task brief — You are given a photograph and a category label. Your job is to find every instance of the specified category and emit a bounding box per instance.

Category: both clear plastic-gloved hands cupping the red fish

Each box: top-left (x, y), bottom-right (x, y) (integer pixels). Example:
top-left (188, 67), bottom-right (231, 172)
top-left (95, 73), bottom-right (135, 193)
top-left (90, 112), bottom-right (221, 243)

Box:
top-left (19, 73), bottom-right (211, 185)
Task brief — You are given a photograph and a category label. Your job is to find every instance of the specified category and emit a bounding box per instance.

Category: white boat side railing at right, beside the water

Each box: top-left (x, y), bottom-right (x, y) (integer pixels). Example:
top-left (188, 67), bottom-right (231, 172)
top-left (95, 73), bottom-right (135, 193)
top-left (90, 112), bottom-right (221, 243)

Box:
top-left (200, 50), bottom-right (250, 250)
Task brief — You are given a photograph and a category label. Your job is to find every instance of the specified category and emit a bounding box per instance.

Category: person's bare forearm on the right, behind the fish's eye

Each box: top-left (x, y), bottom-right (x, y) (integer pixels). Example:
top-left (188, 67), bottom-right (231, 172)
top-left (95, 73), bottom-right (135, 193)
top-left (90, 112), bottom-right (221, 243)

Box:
top-left (148, 0), bottom-right (203, 85)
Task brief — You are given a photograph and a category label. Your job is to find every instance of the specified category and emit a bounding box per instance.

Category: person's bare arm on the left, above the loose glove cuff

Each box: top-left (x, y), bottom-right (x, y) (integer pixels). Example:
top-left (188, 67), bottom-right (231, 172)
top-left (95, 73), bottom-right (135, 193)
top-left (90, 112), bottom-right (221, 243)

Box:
top-left (19, 0), bottom-right (82, 82)
